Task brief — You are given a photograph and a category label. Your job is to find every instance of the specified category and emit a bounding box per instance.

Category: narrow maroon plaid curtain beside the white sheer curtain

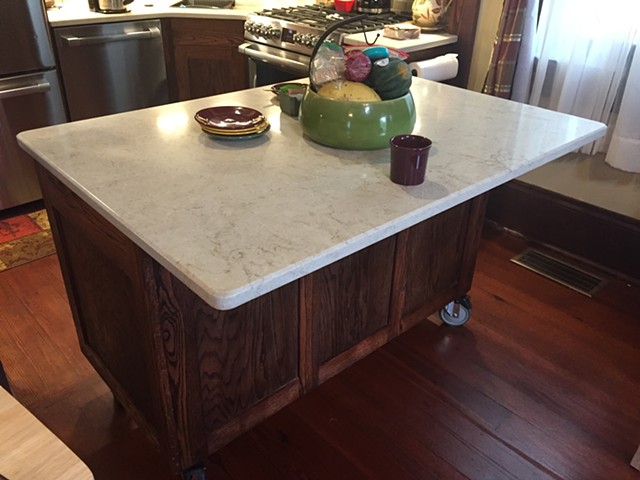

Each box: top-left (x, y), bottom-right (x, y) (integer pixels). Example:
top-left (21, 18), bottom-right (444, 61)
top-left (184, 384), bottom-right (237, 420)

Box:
top-left (482, 0), bottom-right (528, 98)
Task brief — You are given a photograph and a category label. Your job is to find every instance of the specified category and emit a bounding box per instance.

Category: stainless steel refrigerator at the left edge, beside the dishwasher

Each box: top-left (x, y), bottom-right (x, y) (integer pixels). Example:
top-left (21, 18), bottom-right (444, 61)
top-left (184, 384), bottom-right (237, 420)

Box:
top-left (0, 0), bottom-right (67, 210)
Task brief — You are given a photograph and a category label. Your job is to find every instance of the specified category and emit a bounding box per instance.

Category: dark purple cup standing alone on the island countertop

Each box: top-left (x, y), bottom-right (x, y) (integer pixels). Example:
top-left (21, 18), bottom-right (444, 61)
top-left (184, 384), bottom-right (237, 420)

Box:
top-left (389, 135), bottom-right (432, 185)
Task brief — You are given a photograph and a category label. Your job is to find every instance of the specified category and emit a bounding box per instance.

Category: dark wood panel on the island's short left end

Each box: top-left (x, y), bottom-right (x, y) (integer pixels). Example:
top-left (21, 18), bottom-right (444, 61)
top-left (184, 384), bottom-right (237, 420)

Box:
top-left (38, 167), bottom-right (167, 450)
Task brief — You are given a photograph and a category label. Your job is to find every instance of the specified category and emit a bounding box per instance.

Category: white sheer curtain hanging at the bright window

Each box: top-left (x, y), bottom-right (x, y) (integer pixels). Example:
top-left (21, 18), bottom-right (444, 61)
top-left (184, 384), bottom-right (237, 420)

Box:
top-left (529, 0), bottom-right (640, 170)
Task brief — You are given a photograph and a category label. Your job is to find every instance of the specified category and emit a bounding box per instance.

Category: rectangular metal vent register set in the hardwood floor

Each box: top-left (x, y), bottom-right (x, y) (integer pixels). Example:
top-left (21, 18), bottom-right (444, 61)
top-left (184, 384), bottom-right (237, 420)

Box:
top-left (511, 248), bottom-right (604, 297)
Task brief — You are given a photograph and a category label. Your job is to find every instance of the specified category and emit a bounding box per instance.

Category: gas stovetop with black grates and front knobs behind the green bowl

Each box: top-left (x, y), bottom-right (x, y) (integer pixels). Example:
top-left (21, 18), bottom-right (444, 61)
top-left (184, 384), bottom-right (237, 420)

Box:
top-left (244, 5), bottom-right (410, 55)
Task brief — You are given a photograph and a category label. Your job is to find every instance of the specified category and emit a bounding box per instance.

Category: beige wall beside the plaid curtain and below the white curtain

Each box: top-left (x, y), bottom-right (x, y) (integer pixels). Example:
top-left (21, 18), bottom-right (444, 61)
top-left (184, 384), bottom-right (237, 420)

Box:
top-left (469, 0), bottom-right (640, 220)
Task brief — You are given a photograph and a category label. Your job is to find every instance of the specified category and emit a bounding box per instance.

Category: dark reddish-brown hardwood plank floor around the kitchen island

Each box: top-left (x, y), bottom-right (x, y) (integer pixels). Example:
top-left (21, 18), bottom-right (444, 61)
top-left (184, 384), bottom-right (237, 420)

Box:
top-left (0, 226), bottom-right (640, 480)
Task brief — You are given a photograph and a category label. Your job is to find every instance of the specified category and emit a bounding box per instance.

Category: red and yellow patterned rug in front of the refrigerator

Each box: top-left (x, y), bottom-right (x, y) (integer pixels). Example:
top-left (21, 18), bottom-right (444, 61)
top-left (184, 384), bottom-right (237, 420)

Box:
top-left (0, 210), bottom-right (56, 272)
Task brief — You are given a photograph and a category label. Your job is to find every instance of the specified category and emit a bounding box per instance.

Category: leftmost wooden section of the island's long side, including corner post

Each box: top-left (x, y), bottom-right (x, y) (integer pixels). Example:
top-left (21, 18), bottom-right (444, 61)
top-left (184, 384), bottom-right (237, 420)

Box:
top-left (152, 270), bottom-right (301, 453)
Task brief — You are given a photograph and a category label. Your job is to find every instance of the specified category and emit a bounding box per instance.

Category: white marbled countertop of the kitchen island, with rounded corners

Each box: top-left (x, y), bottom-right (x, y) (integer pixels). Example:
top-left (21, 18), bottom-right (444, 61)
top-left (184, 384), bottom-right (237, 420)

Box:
top-left (18, 79), bottom-right (605, 310)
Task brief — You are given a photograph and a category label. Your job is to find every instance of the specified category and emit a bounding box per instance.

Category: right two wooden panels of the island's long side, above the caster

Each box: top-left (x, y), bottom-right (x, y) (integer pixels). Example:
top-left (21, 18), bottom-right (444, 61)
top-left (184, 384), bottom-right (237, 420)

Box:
top-left (299, 195), bottom-right (486, 392)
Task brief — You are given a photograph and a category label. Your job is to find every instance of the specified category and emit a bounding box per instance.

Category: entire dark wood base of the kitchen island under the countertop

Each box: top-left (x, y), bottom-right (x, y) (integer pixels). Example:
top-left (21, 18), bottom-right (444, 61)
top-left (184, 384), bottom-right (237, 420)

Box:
top-left (38, 167), bottom-right (486, 472)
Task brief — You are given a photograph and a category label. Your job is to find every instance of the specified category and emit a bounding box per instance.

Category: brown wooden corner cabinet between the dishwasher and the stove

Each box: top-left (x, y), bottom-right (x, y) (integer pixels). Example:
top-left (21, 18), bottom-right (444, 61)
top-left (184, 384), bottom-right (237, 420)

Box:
top-left (163, 18), bottom-right (249, 101)
